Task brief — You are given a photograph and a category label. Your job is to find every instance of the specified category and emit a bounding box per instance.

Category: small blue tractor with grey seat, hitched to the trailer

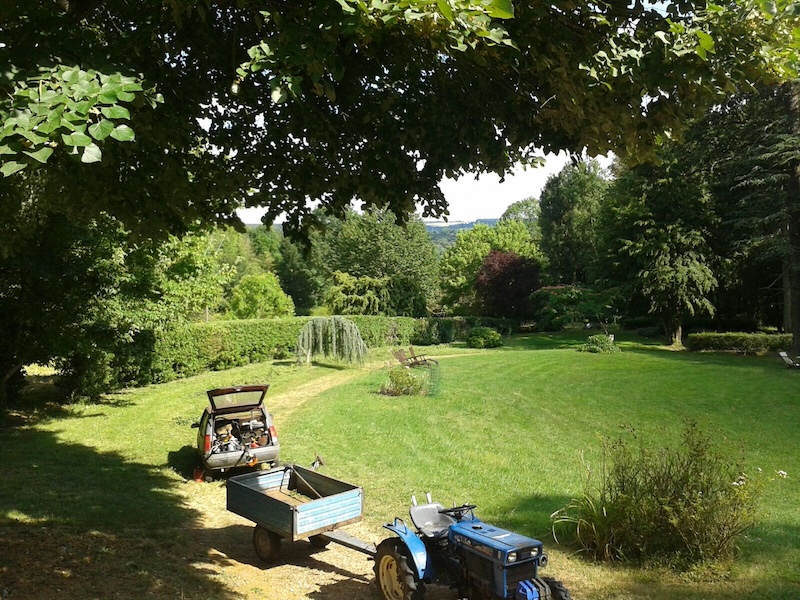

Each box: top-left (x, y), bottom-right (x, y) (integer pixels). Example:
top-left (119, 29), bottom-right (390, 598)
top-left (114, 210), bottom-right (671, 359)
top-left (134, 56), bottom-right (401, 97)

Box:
top-left (375, 494), bottom-right (571, 600)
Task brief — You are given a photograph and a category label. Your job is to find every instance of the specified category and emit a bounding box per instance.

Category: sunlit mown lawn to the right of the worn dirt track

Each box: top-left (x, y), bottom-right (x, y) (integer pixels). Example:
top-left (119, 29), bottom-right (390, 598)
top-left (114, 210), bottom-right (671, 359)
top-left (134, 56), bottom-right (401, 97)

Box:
top-left (284, 339), bottom-right (800, 598)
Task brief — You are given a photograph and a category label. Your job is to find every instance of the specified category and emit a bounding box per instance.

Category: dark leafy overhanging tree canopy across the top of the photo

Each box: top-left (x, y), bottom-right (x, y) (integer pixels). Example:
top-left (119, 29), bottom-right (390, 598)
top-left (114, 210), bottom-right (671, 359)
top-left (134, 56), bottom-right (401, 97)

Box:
top-left (0, 0), bottom-right (794, 246)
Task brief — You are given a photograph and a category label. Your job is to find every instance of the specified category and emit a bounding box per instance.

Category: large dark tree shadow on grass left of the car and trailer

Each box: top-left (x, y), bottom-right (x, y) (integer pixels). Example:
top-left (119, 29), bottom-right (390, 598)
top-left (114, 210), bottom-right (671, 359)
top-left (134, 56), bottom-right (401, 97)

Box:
top-left (0, 425), bottom-right (238, 600)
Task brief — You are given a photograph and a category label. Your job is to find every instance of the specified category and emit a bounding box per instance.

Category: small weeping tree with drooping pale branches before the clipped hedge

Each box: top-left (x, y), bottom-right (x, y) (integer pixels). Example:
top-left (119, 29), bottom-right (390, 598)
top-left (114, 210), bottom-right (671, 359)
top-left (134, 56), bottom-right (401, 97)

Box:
top-left (297, 317), bottom-right (367, 364)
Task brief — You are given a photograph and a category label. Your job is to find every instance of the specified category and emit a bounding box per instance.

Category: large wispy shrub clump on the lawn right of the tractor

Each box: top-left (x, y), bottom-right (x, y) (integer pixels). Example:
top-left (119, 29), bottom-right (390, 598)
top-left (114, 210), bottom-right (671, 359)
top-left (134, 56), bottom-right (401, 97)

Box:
top-left (553, 423), bottom-right (759, 568)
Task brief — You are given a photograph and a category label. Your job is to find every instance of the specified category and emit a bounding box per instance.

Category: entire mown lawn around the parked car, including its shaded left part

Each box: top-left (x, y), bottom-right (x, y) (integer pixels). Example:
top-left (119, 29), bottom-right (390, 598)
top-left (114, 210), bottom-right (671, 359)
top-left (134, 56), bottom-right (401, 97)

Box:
top-left (0, 333), bottom-right (800, 600)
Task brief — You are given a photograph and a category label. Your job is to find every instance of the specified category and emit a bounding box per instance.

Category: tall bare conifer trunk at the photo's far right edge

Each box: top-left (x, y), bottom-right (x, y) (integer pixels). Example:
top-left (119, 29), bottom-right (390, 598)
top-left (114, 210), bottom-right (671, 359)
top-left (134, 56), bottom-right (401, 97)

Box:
top-left (786, 80), bottom-right (800, 355)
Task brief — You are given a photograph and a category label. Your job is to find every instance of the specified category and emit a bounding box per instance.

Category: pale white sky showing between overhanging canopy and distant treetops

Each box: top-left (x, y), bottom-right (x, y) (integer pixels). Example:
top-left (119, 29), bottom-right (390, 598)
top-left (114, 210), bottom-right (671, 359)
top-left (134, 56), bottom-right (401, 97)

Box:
top-left (238, 153), bottom-right (610, 223)
